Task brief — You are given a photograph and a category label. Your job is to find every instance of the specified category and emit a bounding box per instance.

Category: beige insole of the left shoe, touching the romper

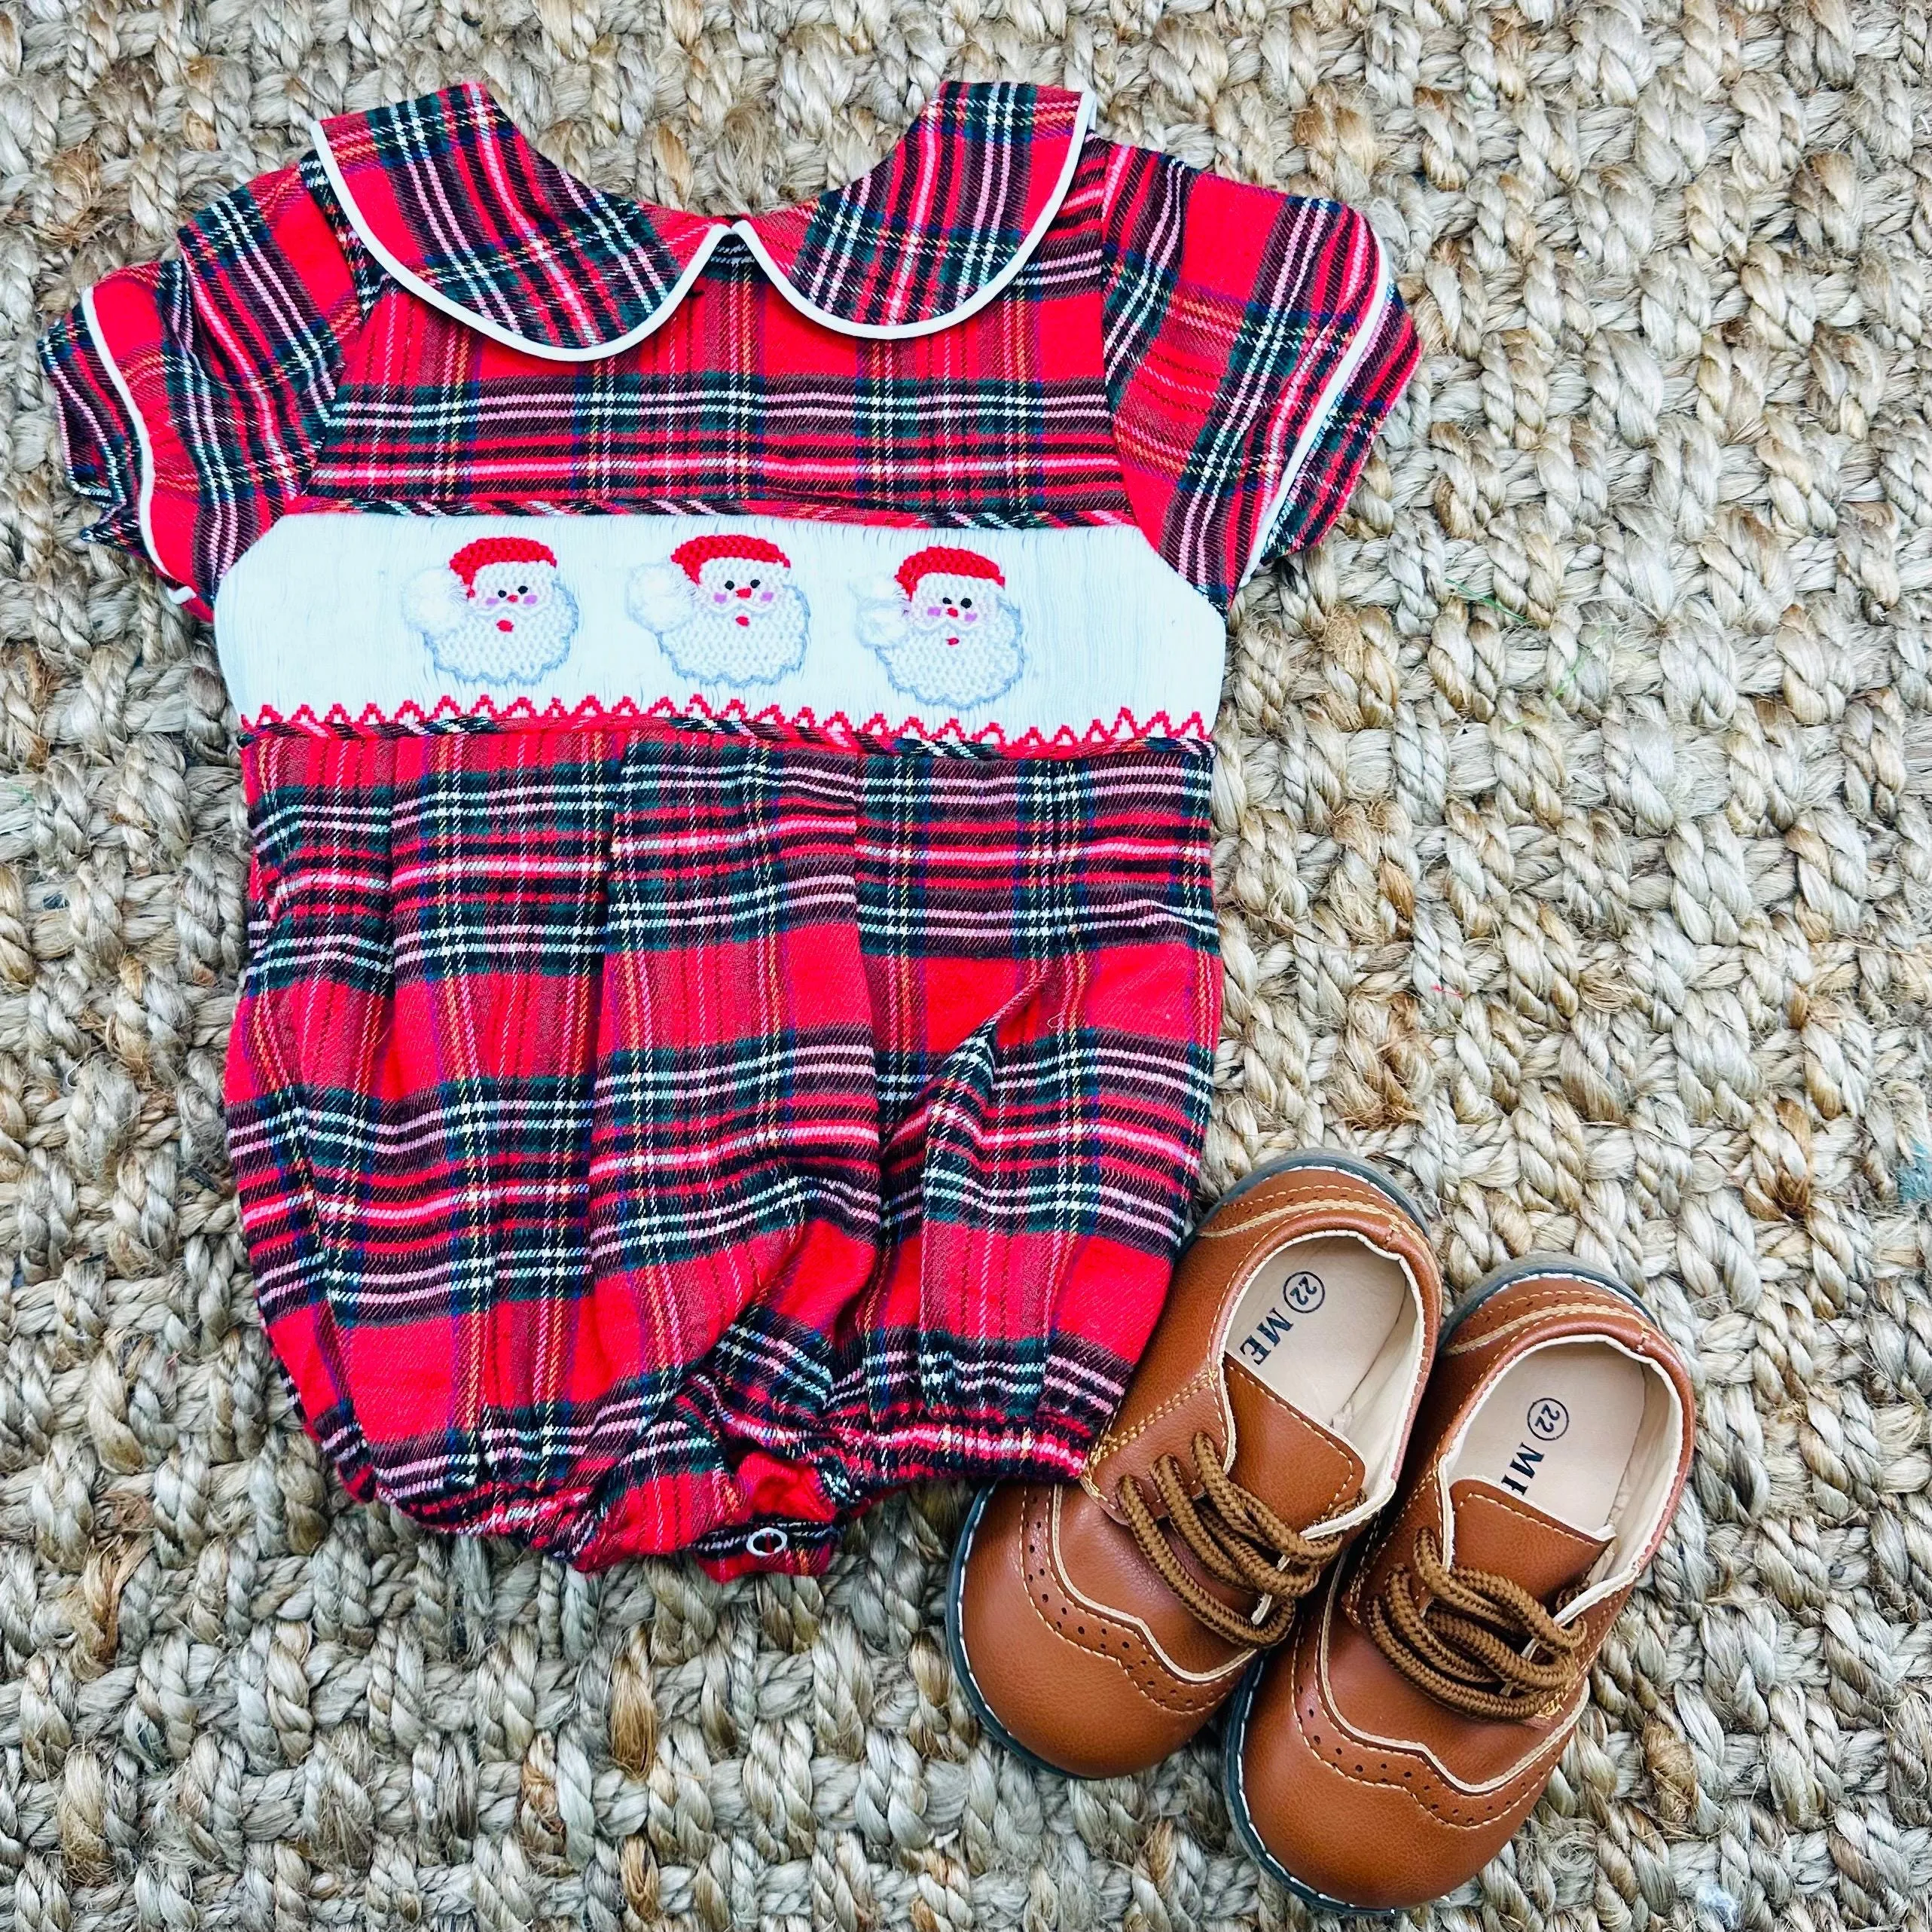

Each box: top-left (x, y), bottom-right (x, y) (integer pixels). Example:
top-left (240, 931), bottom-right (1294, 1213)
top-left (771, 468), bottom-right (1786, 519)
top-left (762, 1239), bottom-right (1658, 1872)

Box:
top-left (1223, 1235), bottom-right (1410, 1460)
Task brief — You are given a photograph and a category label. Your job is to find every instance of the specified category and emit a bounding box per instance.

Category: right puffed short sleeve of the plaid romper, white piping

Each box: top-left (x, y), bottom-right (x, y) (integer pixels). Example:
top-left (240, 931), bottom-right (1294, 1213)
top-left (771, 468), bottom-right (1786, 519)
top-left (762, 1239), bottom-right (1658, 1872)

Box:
top-left (1101, 147), bottom-right (1418, 605)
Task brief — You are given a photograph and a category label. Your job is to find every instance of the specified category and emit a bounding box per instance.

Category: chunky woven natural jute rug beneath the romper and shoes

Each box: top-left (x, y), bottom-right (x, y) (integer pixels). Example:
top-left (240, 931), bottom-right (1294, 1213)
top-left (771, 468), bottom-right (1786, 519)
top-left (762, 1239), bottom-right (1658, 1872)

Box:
top-left (0, 0), bottom-right (1932, 1932)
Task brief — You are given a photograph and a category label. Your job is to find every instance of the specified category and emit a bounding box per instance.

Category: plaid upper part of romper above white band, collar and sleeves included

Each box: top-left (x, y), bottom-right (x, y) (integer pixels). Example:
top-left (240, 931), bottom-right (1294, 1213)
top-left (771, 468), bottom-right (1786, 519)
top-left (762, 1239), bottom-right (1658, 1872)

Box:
top-left (42, 85), bottom-right (1416, 609)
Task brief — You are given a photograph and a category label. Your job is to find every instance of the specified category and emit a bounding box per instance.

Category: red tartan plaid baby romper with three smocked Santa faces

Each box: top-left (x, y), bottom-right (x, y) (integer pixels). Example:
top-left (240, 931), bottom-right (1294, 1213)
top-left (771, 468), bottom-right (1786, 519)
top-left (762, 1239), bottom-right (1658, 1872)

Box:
top-left (42, 83), bottom-right (1416, 1574)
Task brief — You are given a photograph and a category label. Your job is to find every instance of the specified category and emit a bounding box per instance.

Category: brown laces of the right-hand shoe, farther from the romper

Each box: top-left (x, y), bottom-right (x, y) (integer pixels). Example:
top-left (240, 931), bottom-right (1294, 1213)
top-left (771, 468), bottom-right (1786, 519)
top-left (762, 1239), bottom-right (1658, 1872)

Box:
top-left (1362, 1528), bottom-right (1584, 1720)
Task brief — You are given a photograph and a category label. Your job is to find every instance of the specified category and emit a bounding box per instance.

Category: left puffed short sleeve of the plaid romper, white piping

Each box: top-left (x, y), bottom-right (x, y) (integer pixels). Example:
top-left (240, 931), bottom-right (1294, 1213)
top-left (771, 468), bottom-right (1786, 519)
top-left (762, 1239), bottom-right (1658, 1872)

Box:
top-left (41, 168), bottom-right (369, 612)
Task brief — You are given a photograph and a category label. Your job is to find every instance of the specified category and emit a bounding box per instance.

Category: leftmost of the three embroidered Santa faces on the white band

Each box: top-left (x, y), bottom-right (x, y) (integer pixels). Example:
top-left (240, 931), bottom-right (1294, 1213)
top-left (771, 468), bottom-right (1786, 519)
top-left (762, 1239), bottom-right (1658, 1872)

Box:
top-left (404, 537), bottom-right (578, 686)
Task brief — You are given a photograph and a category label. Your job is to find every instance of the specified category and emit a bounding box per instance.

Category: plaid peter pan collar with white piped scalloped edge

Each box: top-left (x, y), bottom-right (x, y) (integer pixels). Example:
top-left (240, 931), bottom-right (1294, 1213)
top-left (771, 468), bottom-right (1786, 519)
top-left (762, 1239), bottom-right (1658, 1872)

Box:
top-left (315, 81), bottom-right (1094, 362)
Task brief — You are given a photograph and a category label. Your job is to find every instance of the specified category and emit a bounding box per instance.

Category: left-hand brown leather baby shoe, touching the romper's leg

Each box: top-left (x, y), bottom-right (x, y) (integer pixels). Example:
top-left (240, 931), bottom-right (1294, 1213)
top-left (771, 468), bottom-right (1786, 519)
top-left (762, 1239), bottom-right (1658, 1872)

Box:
top-left (947, 1153), bottom-right (1441, 1778)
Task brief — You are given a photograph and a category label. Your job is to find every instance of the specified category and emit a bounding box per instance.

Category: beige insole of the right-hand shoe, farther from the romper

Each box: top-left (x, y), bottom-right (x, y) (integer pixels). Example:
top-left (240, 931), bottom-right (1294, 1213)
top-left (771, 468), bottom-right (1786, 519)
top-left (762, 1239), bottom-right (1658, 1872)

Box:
top-left (1449, 1341), bottom-right (1644, 1536)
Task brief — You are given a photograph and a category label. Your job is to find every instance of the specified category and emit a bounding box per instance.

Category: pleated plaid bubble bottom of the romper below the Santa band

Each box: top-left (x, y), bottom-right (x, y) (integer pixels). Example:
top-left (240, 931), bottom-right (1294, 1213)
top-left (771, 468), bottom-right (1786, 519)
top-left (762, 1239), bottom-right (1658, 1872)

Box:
top-left (228, 726), bottom-right (1219, 1563)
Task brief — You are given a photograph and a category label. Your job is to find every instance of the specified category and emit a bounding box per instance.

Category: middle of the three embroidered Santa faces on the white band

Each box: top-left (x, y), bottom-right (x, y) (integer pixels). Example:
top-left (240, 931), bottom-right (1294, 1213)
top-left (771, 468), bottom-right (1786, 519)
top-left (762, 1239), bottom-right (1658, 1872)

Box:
top-left (624, 536), bottom-right (811, 686)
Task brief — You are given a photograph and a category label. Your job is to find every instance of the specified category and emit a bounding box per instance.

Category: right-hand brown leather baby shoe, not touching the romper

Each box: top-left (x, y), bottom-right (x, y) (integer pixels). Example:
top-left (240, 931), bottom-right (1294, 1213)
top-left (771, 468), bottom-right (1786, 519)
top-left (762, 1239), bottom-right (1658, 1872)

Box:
top-left (1227, 1258), bottom-right (1695, 1911)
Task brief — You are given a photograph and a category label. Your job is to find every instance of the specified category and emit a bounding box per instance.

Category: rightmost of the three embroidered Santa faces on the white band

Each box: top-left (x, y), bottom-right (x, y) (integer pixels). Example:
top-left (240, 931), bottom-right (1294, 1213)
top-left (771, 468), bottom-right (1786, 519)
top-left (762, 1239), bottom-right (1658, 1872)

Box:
top-left (858, 543), bottom-right (1026, 707)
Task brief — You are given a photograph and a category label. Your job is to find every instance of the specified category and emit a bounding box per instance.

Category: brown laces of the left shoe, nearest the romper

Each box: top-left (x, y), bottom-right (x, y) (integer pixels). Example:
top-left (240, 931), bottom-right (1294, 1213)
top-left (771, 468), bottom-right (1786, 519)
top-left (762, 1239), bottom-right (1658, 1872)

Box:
top-left (1117, 1430), bottom-right (1341, 1650)
